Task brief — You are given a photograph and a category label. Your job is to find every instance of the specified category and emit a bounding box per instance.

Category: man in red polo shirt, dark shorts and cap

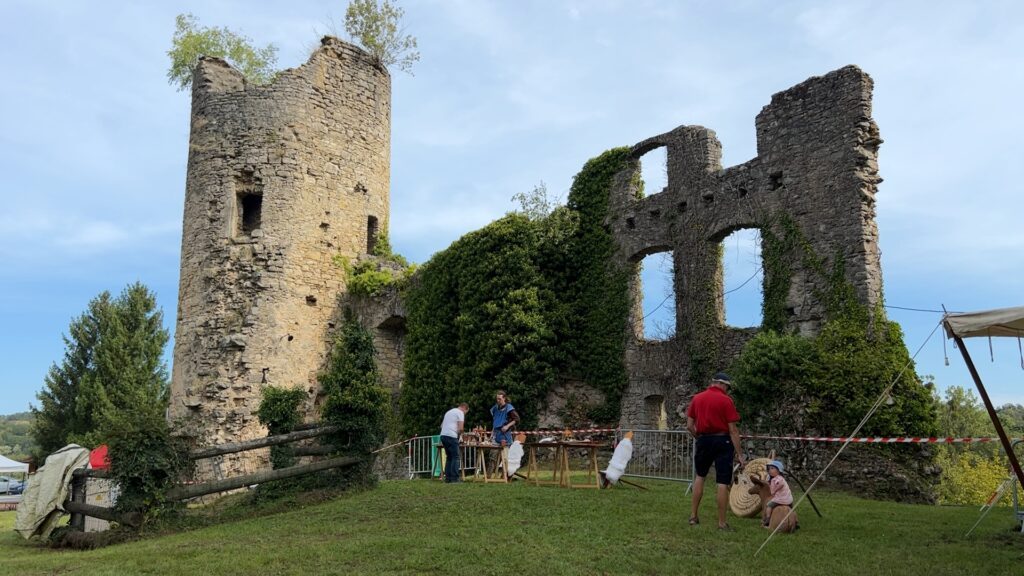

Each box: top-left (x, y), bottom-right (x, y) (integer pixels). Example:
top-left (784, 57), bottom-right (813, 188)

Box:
top-left (686, 372), bottom-right (744, 532)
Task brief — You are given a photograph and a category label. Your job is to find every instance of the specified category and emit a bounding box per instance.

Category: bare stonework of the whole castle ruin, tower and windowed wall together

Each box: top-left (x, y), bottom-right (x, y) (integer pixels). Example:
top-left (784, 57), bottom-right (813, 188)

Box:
top-left (170, 38), bottom-right (882, 453)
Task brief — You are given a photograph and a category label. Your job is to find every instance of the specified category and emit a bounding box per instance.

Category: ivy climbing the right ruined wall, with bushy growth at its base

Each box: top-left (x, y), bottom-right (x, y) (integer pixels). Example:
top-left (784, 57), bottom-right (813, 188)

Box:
top-left (730, 217), bottom-right (937, 436)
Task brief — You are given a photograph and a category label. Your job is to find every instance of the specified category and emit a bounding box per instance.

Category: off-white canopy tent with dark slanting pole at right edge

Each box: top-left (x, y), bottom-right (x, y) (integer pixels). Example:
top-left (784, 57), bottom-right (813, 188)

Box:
top-left (942, 306), bottom-right (1024, 486)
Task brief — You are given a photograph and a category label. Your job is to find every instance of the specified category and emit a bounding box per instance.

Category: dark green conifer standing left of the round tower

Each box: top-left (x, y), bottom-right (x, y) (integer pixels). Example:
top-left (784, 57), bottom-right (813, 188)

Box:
top-left (32, 283), bottom-right (170, 455)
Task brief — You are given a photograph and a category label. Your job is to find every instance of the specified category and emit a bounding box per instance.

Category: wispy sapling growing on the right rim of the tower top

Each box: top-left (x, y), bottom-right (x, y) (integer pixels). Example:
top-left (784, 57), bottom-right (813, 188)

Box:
top-left (345, 0), bottom-right (420, 74)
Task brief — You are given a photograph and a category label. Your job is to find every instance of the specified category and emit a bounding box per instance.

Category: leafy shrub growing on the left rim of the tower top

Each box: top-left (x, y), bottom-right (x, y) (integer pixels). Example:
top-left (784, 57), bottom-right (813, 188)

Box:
top-left (167, 14), bottom-right (278, 91)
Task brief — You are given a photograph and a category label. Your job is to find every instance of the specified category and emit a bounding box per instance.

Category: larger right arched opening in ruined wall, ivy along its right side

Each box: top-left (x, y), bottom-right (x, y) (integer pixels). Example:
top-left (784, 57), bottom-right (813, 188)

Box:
top-left (722, 229), bottom-right (764, 328)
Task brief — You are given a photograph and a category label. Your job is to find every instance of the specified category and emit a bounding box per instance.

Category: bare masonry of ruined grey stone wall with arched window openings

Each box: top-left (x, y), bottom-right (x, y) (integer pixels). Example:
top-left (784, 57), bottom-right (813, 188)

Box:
top-left (608, 67), bottom-right (882, 427)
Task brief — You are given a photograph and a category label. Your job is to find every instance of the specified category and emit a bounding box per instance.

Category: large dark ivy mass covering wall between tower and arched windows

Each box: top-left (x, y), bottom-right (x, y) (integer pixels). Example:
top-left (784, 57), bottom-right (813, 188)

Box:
top-left (400, 149), bottom-right (629, 435)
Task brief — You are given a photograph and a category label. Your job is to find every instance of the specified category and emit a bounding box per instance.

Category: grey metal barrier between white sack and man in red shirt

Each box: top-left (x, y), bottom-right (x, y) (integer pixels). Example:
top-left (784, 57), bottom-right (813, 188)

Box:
top-left (615, 430), bottom-right (693, 484)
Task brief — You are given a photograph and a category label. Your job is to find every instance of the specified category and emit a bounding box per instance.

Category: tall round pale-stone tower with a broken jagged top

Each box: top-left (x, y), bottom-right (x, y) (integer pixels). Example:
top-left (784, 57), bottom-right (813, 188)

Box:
top-left (169, 38), bottom-right (391, 444)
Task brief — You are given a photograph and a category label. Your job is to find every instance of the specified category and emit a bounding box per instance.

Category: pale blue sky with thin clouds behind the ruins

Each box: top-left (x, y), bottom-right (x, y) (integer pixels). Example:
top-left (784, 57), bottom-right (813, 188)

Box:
top-left (0, 0), bottom-right (1024, 414)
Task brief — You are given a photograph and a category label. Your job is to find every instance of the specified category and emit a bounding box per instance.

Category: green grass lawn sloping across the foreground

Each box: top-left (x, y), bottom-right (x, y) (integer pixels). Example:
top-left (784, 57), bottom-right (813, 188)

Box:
top-left (0, 480), bottom-right (1024, 576)
